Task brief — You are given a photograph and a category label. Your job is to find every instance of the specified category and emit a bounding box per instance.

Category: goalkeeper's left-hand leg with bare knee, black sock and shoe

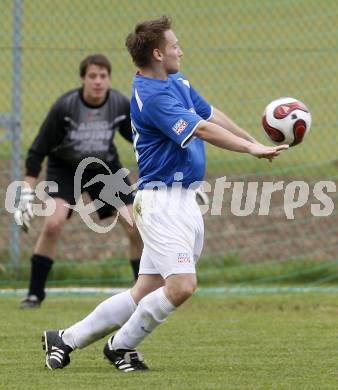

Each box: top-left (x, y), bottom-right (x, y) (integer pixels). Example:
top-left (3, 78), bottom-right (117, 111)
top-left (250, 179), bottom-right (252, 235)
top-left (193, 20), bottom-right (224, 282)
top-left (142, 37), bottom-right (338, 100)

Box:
top-left (20, 198), bottom-right (69, 309)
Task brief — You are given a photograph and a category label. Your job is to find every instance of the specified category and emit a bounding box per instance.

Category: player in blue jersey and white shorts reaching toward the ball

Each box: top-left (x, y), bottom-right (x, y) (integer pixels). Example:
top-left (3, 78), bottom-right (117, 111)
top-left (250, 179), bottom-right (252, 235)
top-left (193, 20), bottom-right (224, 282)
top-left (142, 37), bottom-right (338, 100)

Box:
top-left (43, 16), bottom-right (287, 372)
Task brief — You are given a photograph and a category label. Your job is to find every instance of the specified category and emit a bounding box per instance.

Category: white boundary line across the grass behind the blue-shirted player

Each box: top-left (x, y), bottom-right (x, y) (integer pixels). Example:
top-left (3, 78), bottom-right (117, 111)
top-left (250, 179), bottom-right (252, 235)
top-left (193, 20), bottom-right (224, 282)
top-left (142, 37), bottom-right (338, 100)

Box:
top-left (0, 286), bottom-right (338, 297)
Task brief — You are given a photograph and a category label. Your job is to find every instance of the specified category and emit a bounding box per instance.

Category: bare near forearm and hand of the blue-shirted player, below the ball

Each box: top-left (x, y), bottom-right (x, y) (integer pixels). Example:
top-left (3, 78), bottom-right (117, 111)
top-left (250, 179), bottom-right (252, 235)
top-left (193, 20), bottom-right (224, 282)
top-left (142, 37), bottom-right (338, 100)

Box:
top-left (194, 121), bottom-right (289, 160)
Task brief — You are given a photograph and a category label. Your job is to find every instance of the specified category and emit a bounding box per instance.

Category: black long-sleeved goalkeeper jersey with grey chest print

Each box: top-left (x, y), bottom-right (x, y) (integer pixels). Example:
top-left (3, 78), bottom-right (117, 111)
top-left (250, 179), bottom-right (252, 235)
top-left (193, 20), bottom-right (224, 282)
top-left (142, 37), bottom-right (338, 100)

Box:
top-left (26, 88), bottom-right (132, 177)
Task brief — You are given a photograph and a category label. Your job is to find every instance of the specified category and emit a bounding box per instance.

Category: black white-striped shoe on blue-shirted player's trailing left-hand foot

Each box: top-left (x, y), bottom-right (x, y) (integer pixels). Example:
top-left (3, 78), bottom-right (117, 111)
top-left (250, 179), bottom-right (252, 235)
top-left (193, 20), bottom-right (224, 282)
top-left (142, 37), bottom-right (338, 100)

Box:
top-left (41, 330), bottom-right (72, 370)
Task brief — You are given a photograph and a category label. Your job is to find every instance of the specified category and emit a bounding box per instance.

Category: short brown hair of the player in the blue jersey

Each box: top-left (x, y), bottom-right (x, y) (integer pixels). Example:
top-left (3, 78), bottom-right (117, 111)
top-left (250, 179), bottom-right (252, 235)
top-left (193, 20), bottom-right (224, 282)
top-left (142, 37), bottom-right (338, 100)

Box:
top-left (126, 16), bottom-right (171, 68)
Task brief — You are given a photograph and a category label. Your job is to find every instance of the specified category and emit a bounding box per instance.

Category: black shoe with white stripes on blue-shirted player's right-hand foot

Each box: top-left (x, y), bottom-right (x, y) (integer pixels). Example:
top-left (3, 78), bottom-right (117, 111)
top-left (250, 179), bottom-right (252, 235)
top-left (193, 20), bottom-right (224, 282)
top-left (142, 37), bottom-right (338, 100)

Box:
top-left (103, 336), bottom-right (148, 372)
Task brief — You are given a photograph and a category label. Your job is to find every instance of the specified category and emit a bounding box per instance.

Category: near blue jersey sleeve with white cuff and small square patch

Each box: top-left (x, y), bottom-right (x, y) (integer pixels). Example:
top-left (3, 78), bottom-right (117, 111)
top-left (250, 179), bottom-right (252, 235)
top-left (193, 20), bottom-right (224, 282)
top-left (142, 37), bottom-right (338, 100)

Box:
top-left (142, 94), bottom-right (203, 148)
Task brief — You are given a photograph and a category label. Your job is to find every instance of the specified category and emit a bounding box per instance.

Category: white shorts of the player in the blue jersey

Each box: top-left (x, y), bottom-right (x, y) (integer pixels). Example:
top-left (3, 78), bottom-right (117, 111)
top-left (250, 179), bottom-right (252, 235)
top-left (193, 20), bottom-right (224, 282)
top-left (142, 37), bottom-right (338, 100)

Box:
top-left (134, 188), bottom-right (204, 278)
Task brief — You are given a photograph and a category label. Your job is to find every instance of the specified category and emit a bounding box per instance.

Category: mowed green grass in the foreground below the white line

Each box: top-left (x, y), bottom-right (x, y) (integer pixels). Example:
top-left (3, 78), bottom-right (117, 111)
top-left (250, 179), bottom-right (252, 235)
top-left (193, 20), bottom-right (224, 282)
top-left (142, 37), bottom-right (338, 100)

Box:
top-left (0, 294), bottom-right (338, 390)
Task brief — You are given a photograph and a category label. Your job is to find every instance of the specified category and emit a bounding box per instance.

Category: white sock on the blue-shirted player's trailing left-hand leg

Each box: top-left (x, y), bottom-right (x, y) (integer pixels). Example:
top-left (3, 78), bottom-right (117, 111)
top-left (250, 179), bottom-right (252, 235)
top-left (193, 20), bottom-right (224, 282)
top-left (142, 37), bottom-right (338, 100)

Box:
top-left (62, 290), bottom-right (136, 349)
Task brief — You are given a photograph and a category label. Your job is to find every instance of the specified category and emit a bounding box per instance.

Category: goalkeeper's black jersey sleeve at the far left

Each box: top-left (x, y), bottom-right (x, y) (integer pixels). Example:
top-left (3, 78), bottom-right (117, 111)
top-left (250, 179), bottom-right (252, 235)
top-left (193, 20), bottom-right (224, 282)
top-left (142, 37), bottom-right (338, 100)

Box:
top-left (26, 102), bottom-right (65, 177)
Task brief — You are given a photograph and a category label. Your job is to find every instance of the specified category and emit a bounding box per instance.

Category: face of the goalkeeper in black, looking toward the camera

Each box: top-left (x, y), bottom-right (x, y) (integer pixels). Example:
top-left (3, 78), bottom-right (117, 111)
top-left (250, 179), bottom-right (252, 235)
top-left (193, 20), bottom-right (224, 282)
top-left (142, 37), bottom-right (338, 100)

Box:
top-left (82, 65), bottom-right (110, 105)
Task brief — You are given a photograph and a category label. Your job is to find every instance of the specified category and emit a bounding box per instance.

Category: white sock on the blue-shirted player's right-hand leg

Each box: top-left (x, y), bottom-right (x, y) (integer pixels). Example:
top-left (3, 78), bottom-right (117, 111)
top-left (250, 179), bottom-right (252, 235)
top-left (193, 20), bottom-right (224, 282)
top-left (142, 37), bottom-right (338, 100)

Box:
top-left (112, 287), bottom-right (176, 349)
